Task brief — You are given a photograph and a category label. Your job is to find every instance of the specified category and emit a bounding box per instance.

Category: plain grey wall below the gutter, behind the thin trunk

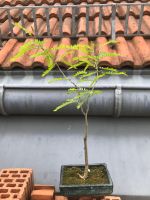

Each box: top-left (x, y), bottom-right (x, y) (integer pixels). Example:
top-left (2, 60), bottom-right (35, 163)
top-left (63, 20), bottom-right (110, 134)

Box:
top-left (0, 116), bottom-right (150, 196)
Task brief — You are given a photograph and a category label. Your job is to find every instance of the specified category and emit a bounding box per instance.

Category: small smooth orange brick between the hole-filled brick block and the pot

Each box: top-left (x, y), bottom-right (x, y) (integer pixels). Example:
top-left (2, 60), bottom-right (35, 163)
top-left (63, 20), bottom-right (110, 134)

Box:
top-left (31, 189), bottom-right (54, 200)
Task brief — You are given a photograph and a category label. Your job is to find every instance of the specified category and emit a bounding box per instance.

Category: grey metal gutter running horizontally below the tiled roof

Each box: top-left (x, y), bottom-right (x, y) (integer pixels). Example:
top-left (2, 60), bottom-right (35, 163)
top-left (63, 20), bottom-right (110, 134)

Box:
top-left (0, 70), bottom-right (150, 117)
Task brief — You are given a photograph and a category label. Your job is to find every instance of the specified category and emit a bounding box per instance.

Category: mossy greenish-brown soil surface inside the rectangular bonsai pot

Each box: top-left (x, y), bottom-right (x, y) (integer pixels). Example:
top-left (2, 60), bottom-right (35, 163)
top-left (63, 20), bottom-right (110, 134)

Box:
top-left (63, 166), bottom-right (109, 185)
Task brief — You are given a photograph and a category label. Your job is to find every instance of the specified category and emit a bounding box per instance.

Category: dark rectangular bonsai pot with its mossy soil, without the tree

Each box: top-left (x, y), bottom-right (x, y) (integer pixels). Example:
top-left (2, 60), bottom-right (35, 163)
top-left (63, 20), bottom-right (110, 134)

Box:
top-left (59, 163), bottom-right (113, 197)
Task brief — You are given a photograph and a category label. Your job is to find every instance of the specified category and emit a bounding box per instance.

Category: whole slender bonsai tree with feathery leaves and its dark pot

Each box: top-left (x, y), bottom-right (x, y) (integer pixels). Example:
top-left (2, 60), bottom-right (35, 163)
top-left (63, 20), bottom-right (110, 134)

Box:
top-left (12, 25), bottom-right (125, 196)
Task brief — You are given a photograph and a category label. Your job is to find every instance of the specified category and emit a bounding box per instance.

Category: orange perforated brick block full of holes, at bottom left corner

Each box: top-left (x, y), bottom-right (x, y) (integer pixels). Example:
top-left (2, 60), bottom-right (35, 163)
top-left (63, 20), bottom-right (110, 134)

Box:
top-left (0, 168), bottom-right (33, 200)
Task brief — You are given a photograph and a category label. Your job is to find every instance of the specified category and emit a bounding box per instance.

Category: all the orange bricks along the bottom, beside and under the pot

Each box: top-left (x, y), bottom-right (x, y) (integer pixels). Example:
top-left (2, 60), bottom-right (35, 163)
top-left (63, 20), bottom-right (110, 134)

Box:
top-left (0, 168), bottom-right (121, 200)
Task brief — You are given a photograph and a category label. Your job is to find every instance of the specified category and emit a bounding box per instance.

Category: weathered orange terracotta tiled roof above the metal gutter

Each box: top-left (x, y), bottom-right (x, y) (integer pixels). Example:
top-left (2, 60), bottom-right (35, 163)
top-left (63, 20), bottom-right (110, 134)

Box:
top-left (0, 0), bottom-right (150, 69)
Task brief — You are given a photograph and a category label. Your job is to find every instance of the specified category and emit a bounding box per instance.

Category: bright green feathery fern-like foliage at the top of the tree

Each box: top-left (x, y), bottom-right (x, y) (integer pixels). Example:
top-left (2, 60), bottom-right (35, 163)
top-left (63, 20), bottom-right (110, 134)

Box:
top-left (12, 23), bottom-right (126, 112)
